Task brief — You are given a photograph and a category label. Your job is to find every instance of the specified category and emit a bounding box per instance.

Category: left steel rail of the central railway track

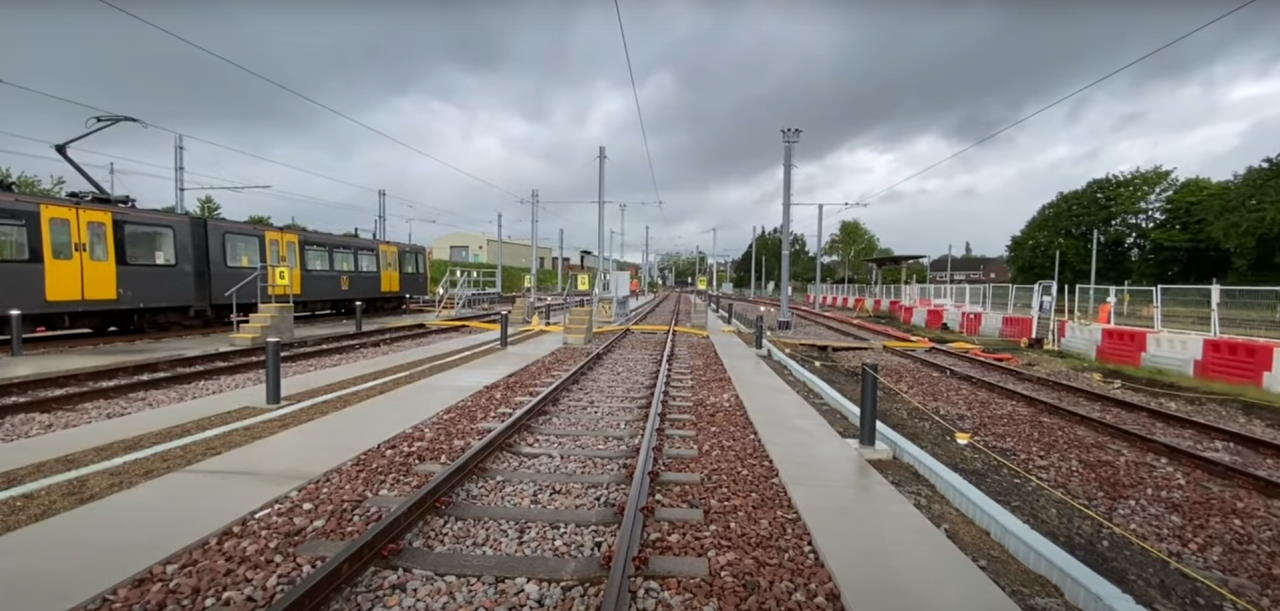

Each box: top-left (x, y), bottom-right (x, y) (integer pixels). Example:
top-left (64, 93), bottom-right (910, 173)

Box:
top-left (270, 292), bottom-right (667, 611)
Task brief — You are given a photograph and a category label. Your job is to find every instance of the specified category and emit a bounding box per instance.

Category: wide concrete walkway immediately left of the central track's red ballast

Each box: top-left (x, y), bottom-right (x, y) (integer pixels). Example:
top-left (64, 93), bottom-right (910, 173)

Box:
top-left (0, 333), bottom-right (561, 611)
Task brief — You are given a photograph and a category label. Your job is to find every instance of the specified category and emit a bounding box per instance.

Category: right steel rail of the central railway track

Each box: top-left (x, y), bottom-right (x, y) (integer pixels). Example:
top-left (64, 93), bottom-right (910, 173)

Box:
top-left (602, 295), bottom-right (680, 611)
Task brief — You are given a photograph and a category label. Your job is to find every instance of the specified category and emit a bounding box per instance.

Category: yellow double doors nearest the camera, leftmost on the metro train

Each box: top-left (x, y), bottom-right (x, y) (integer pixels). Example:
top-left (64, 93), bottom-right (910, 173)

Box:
top-left (40, 204), bottom-right (118, 301)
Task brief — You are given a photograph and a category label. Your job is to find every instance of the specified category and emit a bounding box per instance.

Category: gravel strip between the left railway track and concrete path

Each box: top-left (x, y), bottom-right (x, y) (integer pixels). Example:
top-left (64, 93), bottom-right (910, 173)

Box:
top-left (0, 328), bottom-right (476, 443)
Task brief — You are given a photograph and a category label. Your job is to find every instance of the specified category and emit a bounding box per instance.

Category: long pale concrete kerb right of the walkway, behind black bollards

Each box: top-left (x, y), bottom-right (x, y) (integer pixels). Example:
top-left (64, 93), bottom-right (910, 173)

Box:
top-left (740, 335), bottom-right (1143, 611)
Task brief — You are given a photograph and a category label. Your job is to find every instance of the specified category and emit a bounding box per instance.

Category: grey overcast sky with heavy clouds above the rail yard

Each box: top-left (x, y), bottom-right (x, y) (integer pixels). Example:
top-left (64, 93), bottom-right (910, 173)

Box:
top-left (0, 0), bottom-right (1280, 257)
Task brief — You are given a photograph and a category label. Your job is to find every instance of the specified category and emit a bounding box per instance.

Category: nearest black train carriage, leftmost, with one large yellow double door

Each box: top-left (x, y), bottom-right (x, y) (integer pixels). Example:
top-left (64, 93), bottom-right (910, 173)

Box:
top-left (0, 192), bottom-right (209, 330)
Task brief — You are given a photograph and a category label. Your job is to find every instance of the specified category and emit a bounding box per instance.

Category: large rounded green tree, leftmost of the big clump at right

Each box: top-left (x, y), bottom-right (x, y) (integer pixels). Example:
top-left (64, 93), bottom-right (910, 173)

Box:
top-left (1007, 165), bottom-right (1178, 284)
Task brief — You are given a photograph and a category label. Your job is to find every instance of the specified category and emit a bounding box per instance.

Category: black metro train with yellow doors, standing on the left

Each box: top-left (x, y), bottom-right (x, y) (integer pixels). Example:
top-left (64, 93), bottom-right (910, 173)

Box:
top-left (0, 191), bottom-right (428, 332)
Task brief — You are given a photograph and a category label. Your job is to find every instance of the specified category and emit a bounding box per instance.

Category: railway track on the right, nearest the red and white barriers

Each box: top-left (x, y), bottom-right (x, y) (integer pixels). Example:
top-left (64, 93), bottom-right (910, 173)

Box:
top-left (727, 294), bottom-right (1280, 498)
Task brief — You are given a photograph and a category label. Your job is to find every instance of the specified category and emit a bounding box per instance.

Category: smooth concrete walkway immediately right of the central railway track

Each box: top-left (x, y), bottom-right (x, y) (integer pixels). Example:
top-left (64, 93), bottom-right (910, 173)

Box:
top-left (708, 309), bottom-right (1018, 611)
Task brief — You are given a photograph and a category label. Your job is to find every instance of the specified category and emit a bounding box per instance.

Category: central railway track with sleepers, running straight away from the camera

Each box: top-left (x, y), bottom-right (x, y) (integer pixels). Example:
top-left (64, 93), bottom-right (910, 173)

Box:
top-left (273, 290), bottom-right (705, 610)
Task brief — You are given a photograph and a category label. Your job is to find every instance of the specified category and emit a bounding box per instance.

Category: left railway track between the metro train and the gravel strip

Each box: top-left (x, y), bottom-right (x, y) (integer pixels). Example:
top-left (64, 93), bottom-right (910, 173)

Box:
top-left (0, 313), bottom-right (498, 415)
